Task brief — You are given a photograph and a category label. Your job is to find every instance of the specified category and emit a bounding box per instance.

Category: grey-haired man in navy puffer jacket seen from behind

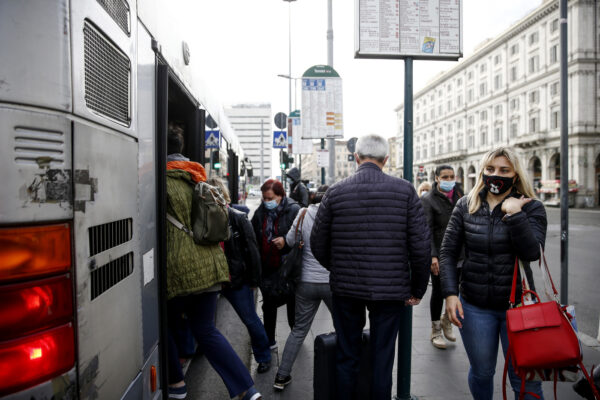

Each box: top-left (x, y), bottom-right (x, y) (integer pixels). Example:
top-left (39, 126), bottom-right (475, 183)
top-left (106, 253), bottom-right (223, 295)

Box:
top-left (310, 135), bottom-right (431, 400)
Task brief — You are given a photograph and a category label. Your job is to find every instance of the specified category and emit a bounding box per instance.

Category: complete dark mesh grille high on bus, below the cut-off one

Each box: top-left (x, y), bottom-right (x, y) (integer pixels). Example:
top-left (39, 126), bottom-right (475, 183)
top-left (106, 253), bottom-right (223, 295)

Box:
top-left (83, 21), bottom-right (131, 125)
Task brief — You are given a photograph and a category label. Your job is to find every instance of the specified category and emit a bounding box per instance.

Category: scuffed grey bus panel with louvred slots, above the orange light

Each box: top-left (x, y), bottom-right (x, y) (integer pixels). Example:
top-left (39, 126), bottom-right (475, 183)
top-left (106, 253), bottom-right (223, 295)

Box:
top-left (0, 106), bottom-right (73, 224)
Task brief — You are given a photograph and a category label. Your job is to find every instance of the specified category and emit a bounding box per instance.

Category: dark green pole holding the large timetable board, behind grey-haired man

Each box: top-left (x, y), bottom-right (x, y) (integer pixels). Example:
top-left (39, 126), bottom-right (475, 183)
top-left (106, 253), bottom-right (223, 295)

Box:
top-left (396, 57), bottom-right (416, 400)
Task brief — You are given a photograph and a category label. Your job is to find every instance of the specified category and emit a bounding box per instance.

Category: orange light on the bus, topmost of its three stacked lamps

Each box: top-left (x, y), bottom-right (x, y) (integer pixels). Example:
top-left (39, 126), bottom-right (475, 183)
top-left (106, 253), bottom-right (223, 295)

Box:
top-left (0, 224), bottom-right (71, 281)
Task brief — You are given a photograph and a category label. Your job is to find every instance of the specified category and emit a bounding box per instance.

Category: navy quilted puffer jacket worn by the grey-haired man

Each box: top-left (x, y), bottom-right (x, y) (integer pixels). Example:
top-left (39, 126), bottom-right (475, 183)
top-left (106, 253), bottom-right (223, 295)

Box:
top-left (310, 162), bottom-right (431, 301)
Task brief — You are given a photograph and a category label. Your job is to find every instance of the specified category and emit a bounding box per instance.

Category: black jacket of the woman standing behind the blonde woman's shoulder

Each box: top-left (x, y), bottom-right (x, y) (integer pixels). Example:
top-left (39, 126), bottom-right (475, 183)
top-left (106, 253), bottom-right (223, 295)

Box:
top-left (421, 182), bottom-right (463, 258)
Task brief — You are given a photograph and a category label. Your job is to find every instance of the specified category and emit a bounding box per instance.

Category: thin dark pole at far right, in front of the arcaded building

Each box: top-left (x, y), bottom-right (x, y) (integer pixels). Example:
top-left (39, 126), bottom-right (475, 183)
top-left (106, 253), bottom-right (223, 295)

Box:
top-left (560, 0), bottom-right (569, 304)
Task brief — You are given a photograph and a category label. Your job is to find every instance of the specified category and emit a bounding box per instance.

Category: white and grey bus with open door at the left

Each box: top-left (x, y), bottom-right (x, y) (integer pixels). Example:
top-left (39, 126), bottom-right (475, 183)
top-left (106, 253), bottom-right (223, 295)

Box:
top-left (0, 0), bottom-right (243, 399)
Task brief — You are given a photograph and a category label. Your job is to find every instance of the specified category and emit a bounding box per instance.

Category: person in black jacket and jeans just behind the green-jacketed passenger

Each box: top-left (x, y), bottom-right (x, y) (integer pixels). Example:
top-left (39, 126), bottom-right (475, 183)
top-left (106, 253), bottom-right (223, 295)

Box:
top-left (208, 178), bottom-right (271, 374)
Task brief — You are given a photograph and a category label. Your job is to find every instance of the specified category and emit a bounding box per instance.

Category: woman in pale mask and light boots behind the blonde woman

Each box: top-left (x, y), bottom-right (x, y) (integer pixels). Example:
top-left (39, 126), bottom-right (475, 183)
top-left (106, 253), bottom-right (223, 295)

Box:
top-left (421, 165), bottom-right (463, 349)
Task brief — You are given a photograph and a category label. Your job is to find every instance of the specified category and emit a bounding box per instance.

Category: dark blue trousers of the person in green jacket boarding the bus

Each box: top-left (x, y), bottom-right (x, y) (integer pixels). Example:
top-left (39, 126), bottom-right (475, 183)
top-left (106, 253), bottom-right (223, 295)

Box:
top-left (167, 292), bottom-right (254, 398)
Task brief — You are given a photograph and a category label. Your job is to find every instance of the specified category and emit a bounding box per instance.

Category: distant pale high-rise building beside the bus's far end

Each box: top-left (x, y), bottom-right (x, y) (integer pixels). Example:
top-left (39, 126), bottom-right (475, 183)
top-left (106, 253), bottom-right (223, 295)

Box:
top-left (225, 104), bottom-right (273, 184)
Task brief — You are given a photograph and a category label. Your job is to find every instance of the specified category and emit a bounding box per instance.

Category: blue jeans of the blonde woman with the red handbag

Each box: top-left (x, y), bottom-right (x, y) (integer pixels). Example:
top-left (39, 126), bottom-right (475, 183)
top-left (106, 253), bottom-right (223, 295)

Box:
top-left (459, 297), bottom-right (544, 400)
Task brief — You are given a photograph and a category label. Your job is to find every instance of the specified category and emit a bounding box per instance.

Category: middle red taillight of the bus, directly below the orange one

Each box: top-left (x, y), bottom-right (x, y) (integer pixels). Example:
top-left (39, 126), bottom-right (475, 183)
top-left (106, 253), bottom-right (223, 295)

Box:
top-left (0, 274), bottom-right (73, 340)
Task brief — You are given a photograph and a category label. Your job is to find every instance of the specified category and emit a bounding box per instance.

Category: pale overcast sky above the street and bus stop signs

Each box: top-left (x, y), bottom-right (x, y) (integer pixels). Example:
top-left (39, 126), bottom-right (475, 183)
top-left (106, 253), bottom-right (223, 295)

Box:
top-left (179, 0), bottom-right (542, 139)
